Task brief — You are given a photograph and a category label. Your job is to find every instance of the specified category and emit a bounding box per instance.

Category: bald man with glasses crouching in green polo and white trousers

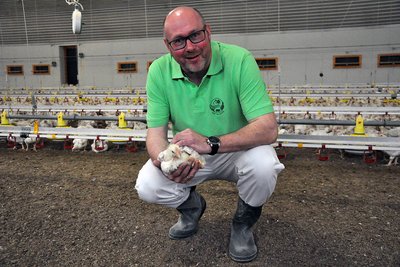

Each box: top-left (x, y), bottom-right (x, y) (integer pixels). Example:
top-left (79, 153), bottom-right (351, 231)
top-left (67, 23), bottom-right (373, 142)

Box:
top-left (135, 7), bottom-right (284, 262)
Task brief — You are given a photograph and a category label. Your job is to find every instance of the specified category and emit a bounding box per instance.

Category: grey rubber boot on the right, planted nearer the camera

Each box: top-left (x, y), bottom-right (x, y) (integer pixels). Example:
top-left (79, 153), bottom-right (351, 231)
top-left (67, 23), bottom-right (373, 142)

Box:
top-left (229, 198), bottom-right (262, 262)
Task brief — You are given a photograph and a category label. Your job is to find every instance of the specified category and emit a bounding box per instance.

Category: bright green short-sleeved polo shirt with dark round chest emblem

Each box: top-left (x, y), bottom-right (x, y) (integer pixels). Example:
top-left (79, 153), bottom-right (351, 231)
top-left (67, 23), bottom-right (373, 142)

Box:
top-left (146, 41), bottom-right (274, 136)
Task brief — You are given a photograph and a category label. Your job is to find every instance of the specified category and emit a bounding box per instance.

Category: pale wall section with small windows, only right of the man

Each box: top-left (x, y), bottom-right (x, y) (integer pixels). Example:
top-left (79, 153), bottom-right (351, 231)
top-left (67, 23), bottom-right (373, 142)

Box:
top-left (217, 26), bottom-right (400, 85)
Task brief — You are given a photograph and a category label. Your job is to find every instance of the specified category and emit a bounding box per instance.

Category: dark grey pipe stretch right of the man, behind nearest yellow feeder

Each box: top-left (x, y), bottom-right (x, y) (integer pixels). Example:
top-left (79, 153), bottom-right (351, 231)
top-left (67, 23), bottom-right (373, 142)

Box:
top-left (278, 119), bottom-right (400, 126)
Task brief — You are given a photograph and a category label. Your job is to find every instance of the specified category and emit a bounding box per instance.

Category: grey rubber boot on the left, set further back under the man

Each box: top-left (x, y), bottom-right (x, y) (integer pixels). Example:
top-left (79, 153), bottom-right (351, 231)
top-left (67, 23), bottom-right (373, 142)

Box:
top-left (169, 187), bottom-right (206, 239)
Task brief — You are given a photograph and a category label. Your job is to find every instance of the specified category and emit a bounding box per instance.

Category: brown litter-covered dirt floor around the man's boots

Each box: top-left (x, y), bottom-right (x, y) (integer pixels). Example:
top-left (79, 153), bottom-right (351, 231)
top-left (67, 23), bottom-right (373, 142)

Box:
top-left (0, 143), bottom-right (400, 266)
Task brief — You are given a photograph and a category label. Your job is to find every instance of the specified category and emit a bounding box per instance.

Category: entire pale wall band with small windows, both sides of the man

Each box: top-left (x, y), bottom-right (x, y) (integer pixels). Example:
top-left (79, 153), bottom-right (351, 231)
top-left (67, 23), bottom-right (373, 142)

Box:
top-left (0, 26), bottom-right (400, 88)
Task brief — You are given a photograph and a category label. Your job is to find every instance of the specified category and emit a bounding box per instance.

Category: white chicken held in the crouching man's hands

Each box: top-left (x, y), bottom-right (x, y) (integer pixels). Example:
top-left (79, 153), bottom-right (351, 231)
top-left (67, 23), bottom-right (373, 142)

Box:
top-left (157, 144), bottom-right (206, 175)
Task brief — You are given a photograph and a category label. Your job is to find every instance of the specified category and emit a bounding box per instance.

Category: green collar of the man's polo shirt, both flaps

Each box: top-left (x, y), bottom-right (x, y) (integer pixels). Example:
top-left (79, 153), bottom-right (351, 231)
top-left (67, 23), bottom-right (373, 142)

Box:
top-left (170, 41), bottom-right (223, 79)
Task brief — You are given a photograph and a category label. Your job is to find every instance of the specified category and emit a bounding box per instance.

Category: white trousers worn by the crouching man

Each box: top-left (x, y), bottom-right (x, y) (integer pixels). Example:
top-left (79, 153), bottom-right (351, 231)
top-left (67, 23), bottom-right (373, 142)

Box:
top-left (135, 145), bottom-right (285, 208)
